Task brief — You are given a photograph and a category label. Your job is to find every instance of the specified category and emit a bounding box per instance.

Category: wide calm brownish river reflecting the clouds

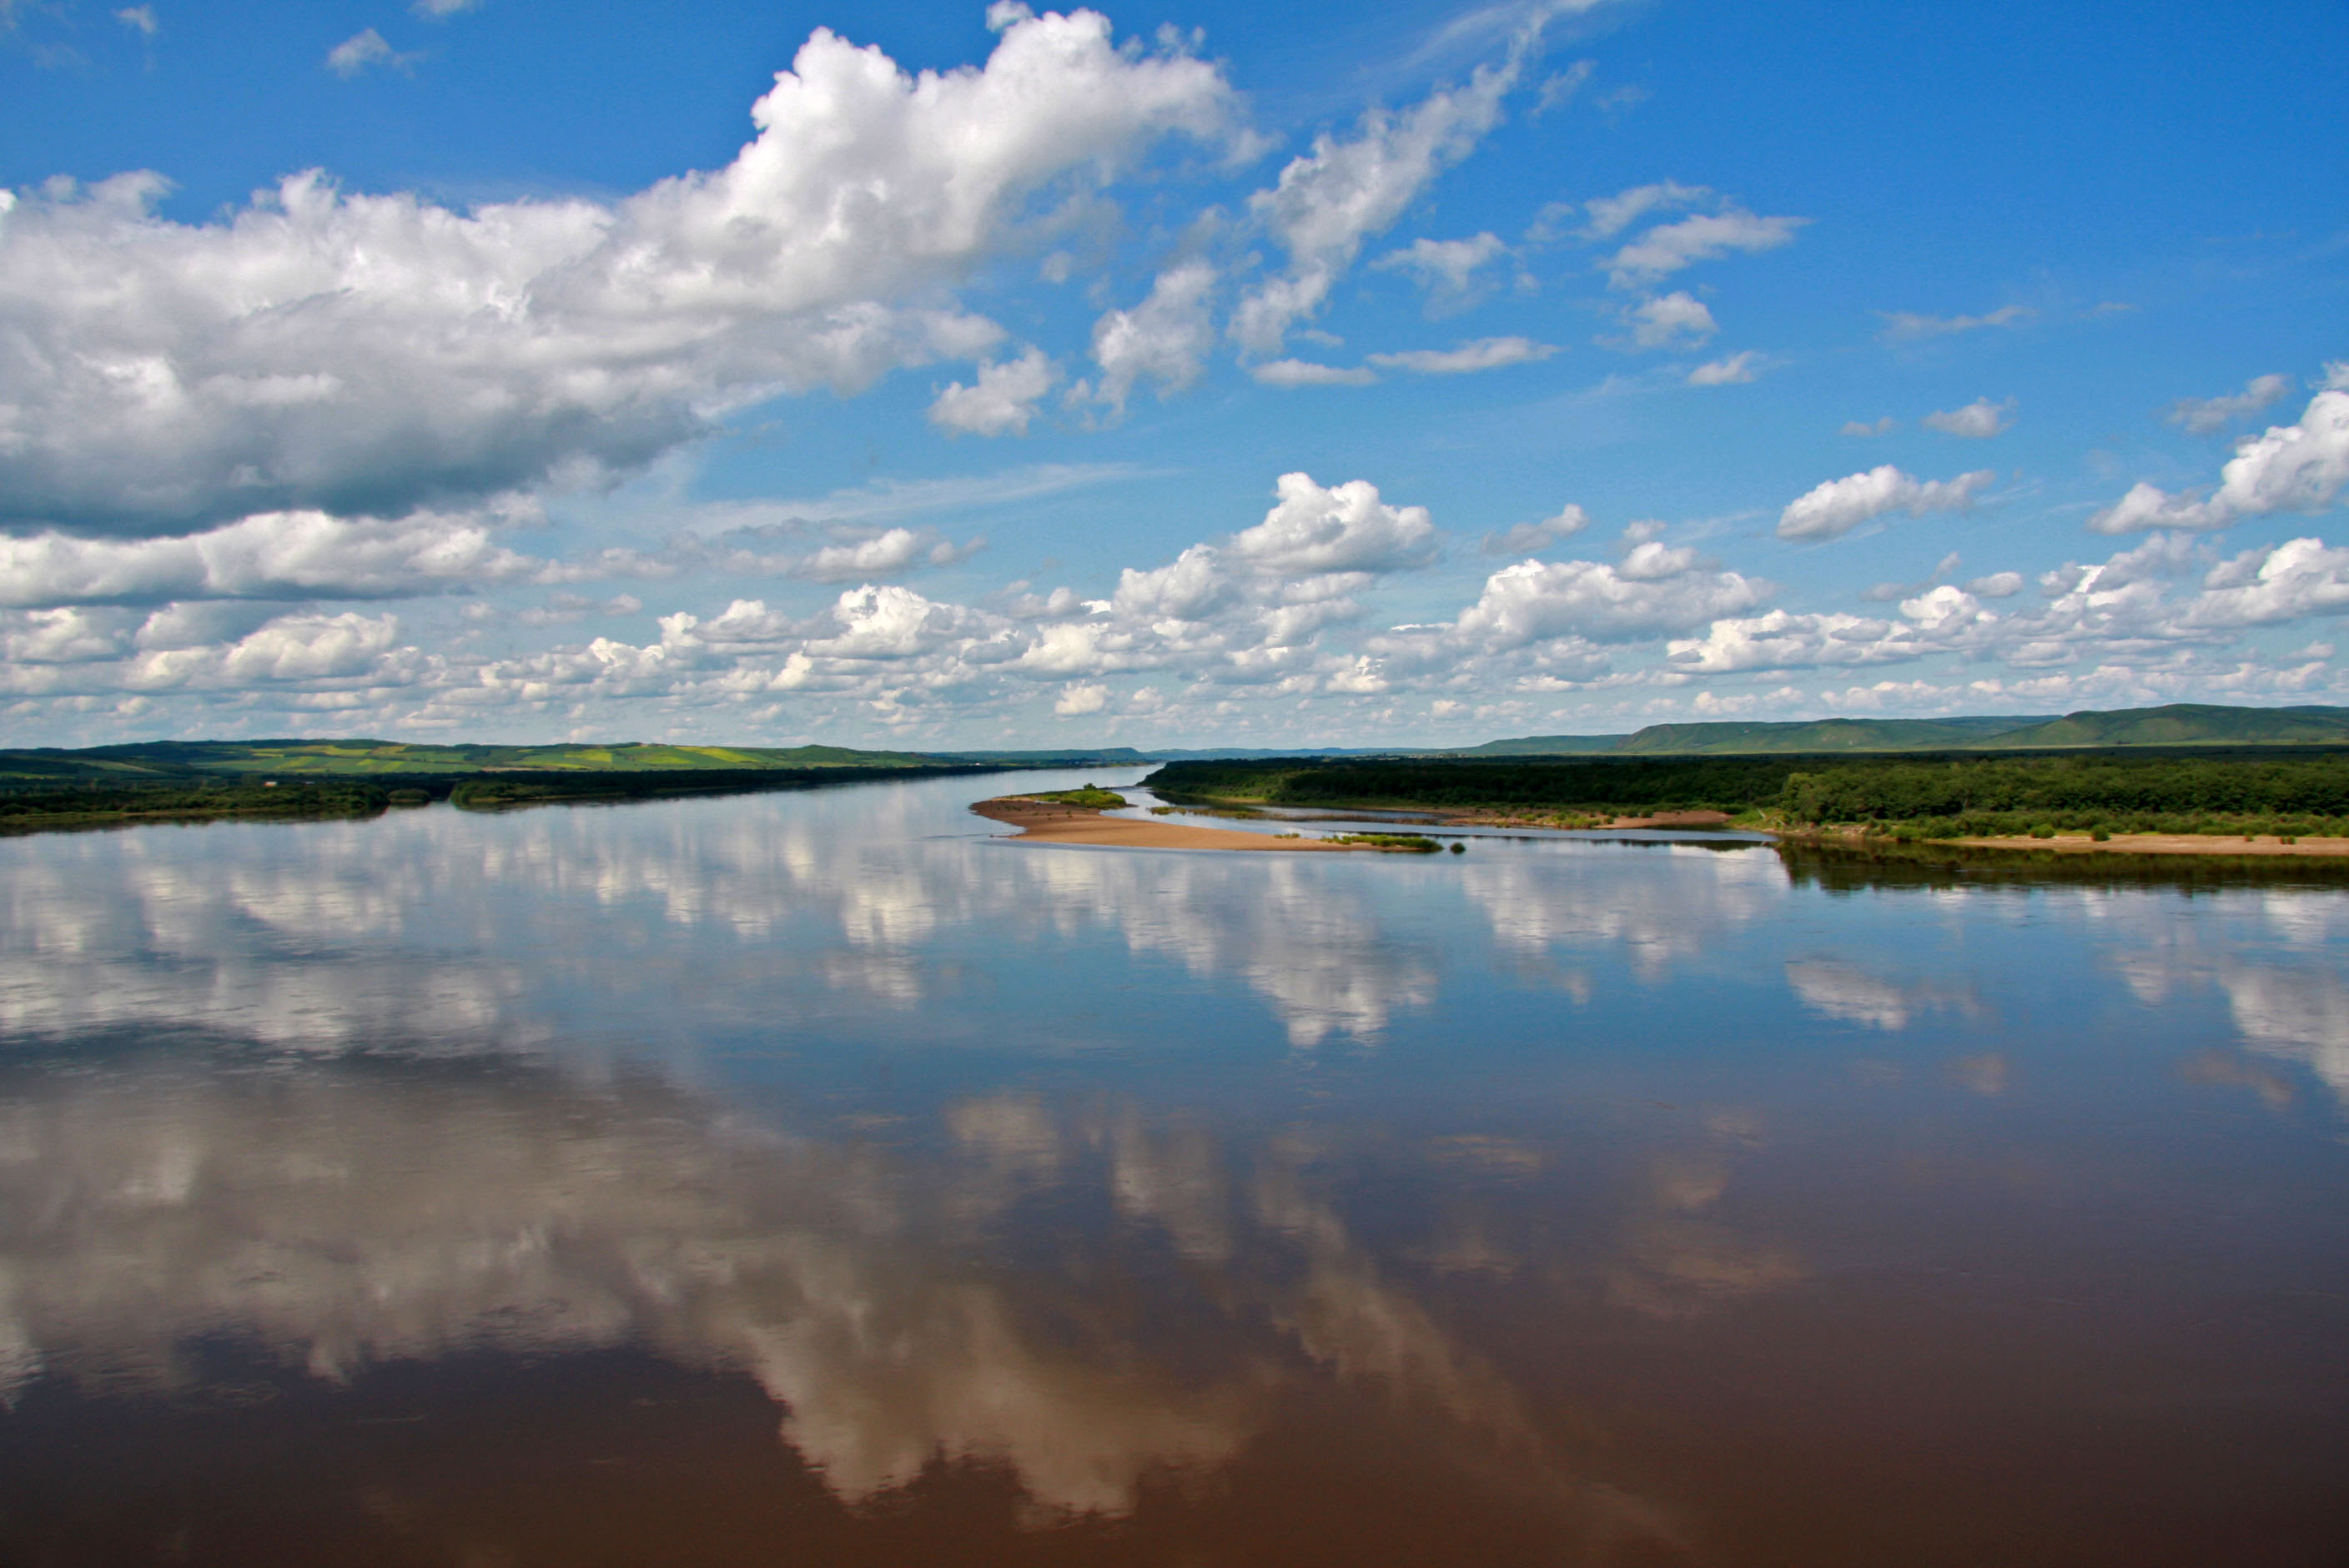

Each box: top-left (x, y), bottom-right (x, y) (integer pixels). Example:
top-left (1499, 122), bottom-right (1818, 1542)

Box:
top-left (0, 770), bottom-right (2349, 1568)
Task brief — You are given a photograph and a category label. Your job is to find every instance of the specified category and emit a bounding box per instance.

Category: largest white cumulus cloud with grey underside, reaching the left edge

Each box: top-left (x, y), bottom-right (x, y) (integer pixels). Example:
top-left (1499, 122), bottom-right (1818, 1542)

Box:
top-left (0, 12), bottom-right (1231, 533)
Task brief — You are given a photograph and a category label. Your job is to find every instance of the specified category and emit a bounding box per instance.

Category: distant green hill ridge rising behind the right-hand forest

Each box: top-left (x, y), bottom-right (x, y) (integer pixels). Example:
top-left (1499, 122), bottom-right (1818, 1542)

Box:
top-left (1423, 701), bottom-right (2349, 756)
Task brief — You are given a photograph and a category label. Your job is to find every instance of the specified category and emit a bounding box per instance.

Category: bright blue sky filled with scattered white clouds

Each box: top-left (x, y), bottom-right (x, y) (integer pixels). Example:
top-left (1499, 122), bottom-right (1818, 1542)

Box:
top-left (0, 0), bottom-right (2349, 749)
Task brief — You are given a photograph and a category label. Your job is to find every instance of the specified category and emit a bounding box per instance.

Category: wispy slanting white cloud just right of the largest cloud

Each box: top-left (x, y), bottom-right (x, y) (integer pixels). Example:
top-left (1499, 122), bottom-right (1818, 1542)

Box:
top-left (1231, 57), bottom-right (1517, 354)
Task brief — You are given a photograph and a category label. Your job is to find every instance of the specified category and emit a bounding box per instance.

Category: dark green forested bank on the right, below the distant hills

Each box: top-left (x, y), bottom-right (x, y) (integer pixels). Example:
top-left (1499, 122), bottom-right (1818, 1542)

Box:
top-left (1149, 751), bottom-right (2349, 838)
